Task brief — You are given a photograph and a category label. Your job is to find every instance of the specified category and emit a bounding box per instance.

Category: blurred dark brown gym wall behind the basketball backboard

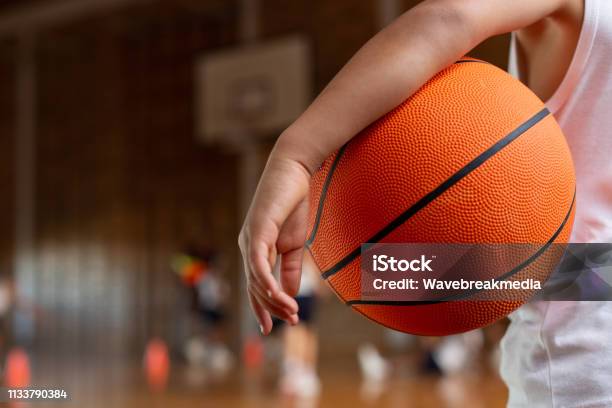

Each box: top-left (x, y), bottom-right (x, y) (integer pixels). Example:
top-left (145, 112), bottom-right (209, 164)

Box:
top-left (0, 0), bottom-right (507, 355)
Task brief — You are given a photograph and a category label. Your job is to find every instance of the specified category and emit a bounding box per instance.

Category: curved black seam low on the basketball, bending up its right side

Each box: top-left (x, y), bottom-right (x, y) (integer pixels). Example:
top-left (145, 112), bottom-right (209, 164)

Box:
top-left (345, 191), bottom-right (576, 306)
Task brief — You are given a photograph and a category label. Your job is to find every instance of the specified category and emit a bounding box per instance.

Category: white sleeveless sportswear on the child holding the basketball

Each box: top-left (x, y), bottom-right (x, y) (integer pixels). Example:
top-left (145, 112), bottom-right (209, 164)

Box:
top-left (501, 0), bottom-right (612, 408)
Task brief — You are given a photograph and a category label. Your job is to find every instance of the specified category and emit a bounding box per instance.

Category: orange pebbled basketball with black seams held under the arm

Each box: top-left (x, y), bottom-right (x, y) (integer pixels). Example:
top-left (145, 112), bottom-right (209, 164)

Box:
top-left (307, 58), bottom-right (576, 335)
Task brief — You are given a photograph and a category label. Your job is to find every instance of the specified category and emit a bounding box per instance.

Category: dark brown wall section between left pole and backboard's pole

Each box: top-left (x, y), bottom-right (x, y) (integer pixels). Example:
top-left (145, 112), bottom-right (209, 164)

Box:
top-left (31, 3), bottom-right (238, 354)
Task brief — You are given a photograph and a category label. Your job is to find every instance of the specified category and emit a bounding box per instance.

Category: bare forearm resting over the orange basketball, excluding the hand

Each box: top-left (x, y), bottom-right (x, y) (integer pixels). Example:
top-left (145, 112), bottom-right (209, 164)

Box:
top-left (273, 0), bottom-right (567, 172)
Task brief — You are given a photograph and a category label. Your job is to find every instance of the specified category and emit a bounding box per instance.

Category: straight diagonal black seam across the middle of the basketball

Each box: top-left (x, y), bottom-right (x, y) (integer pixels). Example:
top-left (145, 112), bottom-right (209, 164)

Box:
top-left (321, 108), bottom-right (550, 279)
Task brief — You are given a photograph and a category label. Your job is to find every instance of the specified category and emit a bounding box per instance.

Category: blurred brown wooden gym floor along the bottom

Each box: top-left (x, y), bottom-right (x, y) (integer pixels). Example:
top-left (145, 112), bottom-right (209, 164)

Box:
top-left (31, 360), bottom-right (507, 408)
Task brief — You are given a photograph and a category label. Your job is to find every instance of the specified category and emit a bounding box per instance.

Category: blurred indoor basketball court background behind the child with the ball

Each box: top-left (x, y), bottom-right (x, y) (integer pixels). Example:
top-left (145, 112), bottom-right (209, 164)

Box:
top-left (0, 0), bottom-right (520, 408)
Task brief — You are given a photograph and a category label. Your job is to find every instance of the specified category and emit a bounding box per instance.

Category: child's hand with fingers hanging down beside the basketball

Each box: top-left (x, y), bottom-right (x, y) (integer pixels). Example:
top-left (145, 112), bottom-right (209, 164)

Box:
top-left (239, 140), bottom-right (310, 334)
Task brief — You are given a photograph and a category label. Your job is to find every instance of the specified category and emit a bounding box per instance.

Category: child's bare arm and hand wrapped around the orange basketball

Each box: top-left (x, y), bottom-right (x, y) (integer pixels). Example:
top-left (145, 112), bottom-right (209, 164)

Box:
top-left (239, 0), bottom-right (567, 333)
